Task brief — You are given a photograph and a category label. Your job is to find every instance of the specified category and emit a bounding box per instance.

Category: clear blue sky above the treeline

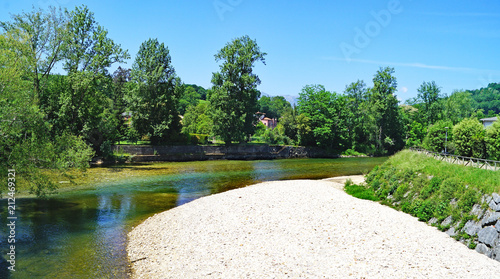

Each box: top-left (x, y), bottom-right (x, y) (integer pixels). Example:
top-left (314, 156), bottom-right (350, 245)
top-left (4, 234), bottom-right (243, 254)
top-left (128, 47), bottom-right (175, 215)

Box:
top-left (0, 0), bottom-right (500, 101)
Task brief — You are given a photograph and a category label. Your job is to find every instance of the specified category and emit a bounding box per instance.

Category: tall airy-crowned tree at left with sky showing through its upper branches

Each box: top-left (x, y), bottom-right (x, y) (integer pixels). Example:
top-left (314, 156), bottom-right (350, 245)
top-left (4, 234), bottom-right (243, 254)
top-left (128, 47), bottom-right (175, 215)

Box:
top-left (47, 6), bottom-right (129, 152)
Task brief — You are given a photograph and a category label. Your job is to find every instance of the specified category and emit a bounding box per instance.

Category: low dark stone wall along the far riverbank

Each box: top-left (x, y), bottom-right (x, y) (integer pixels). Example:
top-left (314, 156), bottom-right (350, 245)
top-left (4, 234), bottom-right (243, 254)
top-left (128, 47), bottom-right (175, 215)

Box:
top-left (112, 145), bottom-right (339, 162)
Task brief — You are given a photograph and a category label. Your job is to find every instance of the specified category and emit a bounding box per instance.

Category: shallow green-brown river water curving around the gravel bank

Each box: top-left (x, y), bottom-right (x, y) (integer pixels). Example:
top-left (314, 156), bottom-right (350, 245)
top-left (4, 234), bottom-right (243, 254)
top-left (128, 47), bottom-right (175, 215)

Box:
top-left (0, 158), bottom-right (386, 278)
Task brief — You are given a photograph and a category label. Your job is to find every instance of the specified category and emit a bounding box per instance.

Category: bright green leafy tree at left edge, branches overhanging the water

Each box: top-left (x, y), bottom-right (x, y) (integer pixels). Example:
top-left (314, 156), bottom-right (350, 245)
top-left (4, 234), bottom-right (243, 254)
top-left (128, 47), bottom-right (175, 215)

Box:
top-left (0, 26), bottom-right (93, 196)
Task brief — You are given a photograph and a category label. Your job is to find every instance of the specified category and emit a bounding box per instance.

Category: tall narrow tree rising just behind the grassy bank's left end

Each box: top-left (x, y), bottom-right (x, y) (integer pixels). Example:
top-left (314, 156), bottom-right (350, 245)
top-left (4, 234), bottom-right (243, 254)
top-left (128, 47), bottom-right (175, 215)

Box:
top-left (368, 67), bottom-right (403, 154)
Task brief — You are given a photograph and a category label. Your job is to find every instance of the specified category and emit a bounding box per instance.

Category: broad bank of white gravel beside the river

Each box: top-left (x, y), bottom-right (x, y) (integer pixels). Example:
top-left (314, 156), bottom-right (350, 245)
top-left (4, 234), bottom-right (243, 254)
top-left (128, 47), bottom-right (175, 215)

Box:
top-left (127, 180), bottom-right (500, 278)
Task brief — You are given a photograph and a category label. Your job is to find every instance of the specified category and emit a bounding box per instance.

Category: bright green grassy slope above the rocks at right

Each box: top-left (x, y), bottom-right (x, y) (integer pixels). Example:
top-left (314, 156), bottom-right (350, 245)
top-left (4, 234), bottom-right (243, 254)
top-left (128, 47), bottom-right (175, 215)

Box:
top-left (366, 150), bottom-right (500, 239)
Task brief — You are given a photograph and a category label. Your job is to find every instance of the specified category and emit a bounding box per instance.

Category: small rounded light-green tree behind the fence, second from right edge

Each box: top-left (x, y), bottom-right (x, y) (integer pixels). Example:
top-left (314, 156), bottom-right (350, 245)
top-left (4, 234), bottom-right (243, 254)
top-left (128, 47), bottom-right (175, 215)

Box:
top-left (453, 118), bottom-right (486, 158)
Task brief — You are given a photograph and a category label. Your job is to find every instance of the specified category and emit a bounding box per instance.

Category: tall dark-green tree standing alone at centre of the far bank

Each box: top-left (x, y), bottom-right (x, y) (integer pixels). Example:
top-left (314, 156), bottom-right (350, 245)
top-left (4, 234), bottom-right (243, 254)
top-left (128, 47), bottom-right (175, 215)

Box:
top-left (208, 36), bottom-right (266, 144)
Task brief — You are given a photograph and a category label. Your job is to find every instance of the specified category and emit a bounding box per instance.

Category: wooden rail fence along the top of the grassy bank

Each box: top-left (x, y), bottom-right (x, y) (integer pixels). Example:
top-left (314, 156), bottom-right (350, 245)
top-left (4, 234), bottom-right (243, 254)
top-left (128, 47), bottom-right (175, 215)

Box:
top-left (410, 147), bottom-right (500, 171)
